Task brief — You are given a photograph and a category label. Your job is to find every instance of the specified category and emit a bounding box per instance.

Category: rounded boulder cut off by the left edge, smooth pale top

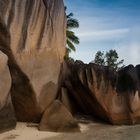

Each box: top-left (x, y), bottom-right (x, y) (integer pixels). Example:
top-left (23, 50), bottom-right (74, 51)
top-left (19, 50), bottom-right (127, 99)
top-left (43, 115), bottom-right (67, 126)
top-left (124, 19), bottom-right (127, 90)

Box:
top-left (0, 50), bottom-right (16, 132)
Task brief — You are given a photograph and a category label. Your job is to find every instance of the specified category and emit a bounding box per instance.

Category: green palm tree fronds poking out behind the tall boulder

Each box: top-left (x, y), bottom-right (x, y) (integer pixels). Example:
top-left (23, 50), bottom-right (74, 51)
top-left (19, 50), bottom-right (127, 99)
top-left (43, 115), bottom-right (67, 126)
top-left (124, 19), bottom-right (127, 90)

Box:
top-left (65, 7), bottom-right (80, 59)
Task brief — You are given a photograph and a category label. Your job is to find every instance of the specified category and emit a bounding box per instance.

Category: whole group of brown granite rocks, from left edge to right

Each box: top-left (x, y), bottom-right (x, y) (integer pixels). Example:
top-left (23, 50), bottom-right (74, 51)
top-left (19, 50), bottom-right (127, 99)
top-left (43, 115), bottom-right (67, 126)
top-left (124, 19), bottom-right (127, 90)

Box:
top-left (0, 0), bottom-right (140, 132)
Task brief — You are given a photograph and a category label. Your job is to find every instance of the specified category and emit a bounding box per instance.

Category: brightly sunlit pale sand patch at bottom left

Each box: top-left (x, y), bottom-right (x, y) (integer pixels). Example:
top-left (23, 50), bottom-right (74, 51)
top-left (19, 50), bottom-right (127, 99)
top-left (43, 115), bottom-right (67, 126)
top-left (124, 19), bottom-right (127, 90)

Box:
top-left (0, 122), bottom-right (60, 140)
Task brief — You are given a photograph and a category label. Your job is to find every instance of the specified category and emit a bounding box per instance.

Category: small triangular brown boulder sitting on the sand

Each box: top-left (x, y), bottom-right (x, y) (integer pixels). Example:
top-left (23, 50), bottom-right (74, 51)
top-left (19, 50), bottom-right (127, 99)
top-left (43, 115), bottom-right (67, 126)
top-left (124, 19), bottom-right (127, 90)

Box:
top-left (39, 100), bottom-right (80, 132)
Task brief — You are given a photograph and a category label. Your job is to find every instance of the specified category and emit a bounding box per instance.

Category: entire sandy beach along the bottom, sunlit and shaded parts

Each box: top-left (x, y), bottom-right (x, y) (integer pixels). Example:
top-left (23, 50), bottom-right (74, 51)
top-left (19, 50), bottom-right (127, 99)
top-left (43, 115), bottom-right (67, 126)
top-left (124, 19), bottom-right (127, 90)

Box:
top-left (0, 122), bottom-right (140, 140)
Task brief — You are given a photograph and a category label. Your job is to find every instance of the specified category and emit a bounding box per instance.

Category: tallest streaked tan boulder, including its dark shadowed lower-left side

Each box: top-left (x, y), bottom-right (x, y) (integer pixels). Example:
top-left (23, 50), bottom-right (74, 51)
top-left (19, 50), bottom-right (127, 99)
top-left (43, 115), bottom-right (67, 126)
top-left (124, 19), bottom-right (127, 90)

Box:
top-left (0, 0), bottom-right (66, 122)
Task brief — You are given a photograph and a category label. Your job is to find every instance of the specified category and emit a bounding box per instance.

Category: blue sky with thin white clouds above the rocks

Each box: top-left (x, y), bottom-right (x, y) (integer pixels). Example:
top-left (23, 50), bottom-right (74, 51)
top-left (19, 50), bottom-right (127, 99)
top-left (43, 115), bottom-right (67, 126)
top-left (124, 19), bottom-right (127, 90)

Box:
top-left (64, 0), bottom-right (140, 65)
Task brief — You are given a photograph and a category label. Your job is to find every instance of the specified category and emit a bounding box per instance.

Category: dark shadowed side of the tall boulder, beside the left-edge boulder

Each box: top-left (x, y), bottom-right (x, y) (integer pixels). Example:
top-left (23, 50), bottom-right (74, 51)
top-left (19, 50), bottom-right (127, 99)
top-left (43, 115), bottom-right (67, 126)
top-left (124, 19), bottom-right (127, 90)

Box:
top-left (0, 14), bottom-right (40, 122)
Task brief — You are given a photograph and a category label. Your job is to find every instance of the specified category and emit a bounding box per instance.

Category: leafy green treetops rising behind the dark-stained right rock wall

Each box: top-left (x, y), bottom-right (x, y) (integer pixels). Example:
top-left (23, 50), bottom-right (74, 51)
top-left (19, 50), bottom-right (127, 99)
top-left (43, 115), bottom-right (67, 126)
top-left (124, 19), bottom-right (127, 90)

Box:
top-left (93, 50), bottom-right (124, 70)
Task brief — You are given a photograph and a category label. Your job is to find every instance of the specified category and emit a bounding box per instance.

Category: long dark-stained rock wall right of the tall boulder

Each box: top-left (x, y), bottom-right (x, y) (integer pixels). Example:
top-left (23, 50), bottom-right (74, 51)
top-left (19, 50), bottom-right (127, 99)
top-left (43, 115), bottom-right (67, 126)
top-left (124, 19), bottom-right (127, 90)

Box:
top-left (59, 62), bottom-right (140, 124)
